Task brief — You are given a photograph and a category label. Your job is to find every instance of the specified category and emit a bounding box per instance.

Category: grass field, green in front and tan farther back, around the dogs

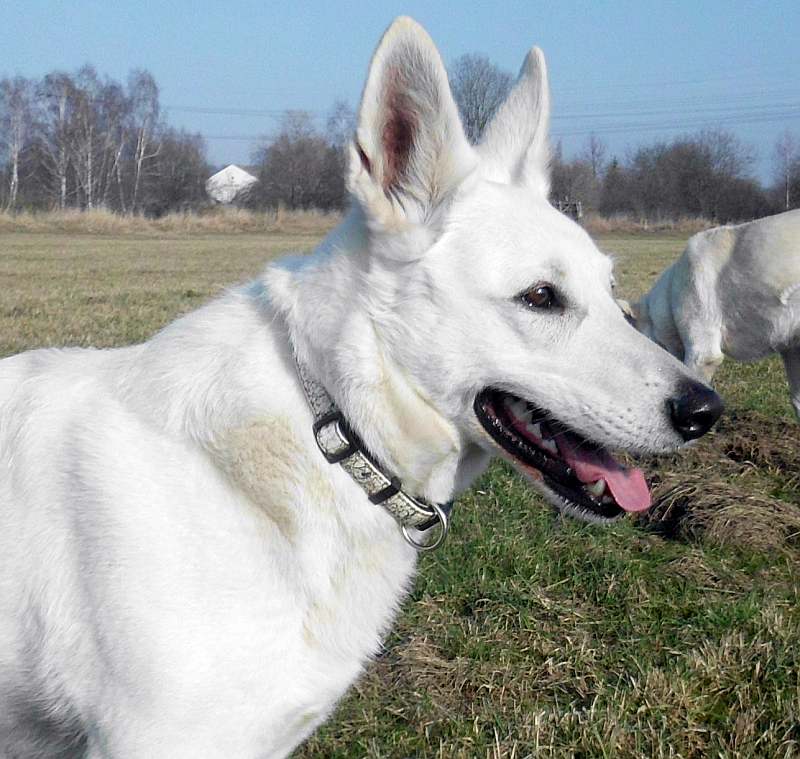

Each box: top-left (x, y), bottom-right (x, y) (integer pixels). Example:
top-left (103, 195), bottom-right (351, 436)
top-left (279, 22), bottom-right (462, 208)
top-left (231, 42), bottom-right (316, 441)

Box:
top-left (0, 230), bottom-right (800, 759)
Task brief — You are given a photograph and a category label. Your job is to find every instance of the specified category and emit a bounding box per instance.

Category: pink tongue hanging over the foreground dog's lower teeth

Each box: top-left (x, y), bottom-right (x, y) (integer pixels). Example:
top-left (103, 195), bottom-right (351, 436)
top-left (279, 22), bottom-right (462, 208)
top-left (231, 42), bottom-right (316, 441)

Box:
top-left (555, 433), bottom-right (650, 511)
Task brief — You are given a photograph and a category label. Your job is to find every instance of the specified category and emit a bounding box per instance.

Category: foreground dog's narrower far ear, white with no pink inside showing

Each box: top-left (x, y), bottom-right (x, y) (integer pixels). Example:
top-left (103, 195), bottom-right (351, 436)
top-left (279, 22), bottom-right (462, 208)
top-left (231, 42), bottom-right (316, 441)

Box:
top-left (478, 47), bottom-right (550, 197)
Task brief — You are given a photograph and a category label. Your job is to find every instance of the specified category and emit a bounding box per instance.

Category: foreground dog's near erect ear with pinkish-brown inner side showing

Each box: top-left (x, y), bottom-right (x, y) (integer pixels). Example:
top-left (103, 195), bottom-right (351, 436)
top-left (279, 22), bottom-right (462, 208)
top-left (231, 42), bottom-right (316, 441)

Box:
top-left (348, 17), bottom-right (477, 229)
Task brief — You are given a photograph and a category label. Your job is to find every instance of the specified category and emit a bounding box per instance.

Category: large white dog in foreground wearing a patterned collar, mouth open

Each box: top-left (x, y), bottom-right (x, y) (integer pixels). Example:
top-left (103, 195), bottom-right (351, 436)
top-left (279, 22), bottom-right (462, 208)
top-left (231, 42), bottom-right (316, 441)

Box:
top-left (0, 14), bottom-right (721, 759)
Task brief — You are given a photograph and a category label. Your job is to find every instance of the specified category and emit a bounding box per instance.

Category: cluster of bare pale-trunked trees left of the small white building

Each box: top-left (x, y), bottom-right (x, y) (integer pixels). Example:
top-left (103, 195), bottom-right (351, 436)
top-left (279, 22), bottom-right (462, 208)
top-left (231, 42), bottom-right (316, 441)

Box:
top-left (0, 66), bottom-right (208, 215)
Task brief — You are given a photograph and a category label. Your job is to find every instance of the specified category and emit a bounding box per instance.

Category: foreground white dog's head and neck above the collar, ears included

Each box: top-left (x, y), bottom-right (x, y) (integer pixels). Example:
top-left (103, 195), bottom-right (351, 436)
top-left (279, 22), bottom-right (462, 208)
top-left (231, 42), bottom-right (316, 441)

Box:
top-left (273, 18), bottom-right (721, 521)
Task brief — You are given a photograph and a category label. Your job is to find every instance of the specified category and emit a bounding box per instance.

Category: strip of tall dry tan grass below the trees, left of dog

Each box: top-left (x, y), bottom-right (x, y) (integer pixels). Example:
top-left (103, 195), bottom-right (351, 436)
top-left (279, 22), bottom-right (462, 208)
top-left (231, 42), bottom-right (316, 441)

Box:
top-left (0, 206), bottom-right (341, 237)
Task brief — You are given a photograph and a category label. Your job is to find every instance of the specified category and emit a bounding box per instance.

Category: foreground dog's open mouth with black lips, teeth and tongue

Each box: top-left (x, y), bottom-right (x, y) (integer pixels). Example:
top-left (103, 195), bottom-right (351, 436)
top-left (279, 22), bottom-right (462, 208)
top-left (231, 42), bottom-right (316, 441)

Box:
top-left (475, 388), bottom-right (650, 522)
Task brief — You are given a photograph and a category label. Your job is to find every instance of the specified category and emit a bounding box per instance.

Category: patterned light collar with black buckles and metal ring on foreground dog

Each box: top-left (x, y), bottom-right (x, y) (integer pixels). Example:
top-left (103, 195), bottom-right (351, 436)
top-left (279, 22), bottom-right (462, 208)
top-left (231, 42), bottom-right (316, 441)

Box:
top-left (295, 354), bottom-right (453, 551)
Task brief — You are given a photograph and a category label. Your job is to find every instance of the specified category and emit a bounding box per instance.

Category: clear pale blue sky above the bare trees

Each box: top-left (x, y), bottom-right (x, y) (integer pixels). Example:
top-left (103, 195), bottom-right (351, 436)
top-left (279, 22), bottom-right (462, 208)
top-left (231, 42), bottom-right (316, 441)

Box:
top-left (6, 0), bottom-right (800, 179)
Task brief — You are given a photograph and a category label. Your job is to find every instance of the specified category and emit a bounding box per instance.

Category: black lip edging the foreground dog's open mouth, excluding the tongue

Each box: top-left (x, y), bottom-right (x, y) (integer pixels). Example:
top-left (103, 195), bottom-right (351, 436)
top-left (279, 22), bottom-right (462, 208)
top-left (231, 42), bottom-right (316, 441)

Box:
top-left (473, 388), bottom-right (624, 520)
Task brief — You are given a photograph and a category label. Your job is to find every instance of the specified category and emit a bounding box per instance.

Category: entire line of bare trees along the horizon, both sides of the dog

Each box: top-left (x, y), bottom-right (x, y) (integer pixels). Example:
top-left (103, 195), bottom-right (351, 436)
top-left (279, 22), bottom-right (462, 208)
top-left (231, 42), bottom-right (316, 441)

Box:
top-left (0, 59), bottom-right (800, 222)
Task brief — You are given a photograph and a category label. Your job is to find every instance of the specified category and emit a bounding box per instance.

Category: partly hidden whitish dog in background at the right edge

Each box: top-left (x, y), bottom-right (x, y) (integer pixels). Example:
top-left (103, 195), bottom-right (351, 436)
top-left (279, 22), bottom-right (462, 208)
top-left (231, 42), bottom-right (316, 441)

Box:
top-left (632, 210), bottom-right (800, 417)
